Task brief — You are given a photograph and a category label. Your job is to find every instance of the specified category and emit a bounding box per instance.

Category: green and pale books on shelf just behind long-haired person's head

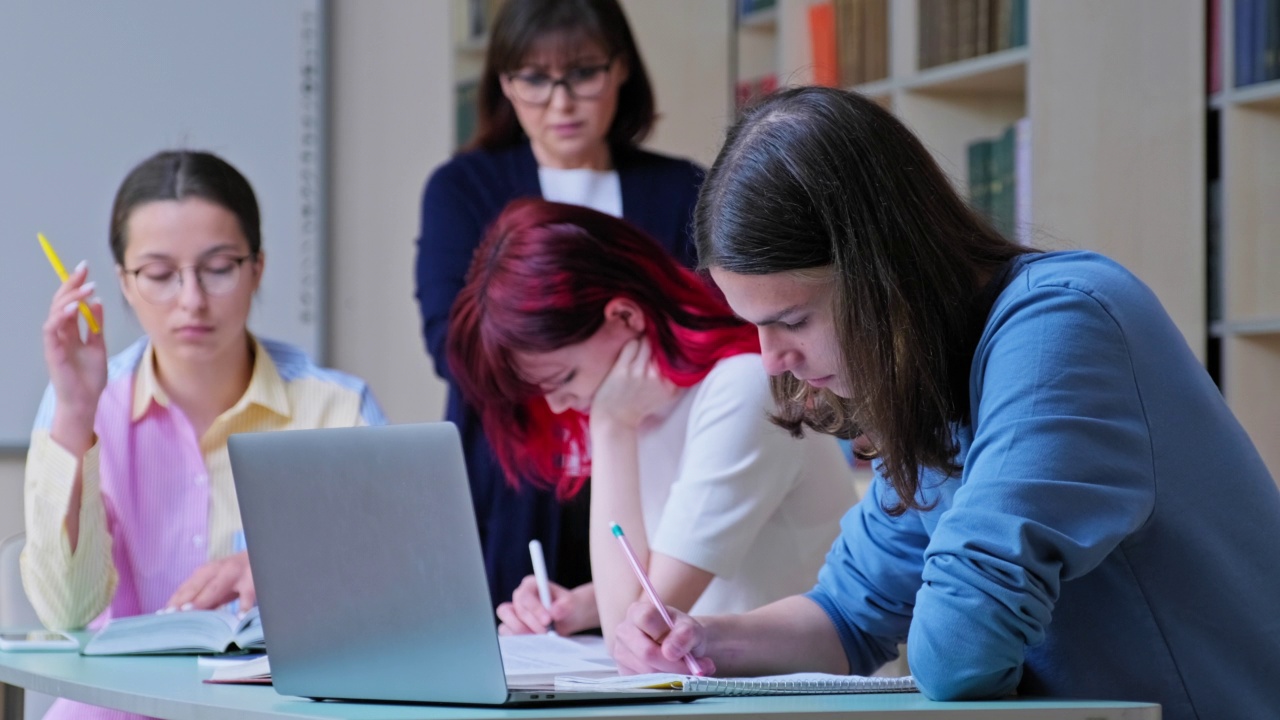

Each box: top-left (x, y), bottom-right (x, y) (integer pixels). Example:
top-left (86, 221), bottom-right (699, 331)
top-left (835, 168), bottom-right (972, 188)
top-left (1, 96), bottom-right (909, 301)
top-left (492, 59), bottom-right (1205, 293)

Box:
top-left (968, 118), bottom-right (1032, 245)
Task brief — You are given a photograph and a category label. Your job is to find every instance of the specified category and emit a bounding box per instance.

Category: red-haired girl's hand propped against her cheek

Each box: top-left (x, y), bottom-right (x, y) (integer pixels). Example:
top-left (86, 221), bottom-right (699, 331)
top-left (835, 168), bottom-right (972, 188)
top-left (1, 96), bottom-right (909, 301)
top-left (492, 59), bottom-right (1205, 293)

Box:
top-left (591, 338), bottom-right (680, 429)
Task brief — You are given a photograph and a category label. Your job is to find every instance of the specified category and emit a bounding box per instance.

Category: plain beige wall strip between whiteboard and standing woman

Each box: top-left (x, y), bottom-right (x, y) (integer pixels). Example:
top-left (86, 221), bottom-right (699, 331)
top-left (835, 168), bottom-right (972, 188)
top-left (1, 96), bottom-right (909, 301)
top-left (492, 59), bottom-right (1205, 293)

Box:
top-left (328, 0), bottom-right (453, 423)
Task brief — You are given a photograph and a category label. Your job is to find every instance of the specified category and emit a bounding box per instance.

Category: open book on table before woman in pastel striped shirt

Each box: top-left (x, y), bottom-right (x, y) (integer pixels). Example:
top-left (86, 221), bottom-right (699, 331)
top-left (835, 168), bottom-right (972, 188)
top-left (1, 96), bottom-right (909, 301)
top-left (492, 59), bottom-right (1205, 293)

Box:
top-left (81, 607), bottom-right (266, 655)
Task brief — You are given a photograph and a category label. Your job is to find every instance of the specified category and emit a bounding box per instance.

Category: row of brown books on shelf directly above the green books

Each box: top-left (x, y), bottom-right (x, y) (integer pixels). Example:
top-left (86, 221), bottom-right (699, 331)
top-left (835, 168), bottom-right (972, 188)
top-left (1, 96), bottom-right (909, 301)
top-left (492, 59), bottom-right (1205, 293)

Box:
top-left (919, 0), bottom-right (1027, 69)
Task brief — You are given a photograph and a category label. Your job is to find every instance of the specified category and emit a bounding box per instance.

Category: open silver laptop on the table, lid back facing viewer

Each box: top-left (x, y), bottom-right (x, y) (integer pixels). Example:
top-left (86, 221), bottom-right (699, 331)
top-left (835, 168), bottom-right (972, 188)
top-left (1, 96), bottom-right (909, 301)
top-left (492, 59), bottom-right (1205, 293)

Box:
top-left (228, 423), bottom-right (704, 705)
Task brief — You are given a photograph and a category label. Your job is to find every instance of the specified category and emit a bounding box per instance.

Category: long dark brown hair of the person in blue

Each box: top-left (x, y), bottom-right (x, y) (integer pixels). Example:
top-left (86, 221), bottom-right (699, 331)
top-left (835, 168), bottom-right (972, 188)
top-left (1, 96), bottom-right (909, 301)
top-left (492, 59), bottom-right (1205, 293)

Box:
top-left (695, 87), bottom-right (1032, 514)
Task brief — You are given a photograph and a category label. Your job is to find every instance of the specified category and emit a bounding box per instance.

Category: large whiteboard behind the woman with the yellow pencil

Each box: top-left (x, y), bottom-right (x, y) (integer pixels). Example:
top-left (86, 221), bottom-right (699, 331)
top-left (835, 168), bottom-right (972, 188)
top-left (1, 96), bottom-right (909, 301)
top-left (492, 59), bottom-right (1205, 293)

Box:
top-left (0, 0), bottom-right (325, 448)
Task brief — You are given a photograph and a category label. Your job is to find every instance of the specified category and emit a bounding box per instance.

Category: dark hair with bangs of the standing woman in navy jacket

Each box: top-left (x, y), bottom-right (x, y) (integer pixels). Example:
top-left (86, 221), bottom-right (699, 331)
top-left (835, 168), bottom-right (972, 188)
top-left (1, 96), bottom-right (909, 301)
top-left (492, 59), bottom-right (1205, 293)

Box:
top-left (466, 0), bottom-right (655, 150)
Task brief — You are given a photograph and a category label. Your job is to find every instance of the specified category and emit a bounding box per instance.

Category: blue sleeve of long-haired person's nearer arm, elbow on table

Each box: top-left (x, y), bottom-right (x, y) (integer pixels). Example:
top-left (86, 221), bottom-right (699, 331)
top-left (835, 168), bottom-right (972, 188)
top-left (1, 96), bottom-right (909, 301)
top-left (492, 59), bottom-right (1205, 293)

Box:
top-left (908, 286), bottom-right (1155, 700)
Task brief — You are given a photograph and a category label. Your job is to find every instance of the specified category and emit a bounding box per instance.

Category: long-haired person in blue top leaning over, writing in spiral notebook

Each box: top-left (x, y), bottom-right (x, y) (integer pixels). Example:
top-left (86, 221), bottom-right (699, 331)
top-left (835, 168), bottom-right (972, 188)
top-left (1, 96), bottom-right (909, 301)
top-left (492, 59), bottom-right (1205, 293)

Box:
top-left (616, 87), bottom-right (1280, 720)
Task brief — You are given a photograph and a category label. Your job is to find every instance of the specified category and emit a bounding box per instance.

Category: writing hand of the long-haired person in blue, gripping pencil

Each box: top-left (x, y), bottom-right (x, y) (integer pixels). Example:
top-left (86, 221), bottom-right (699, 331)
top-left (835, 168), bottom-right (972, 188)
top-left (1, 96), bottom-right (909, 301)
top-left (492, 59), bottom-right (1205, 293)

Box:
top-left (613, 601), bottom-right (716, 675)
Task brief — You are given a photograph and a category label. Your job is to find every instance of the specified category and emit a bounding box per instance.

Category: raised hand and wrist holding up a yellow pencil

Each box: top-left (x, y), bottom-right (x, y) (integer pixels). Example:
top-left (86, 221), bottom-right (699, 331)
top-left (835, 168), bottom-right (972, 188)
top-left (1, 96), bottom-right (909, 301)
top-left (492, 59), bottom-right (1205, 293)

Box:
top-left (42, 263), bottom-right (106, 457)
